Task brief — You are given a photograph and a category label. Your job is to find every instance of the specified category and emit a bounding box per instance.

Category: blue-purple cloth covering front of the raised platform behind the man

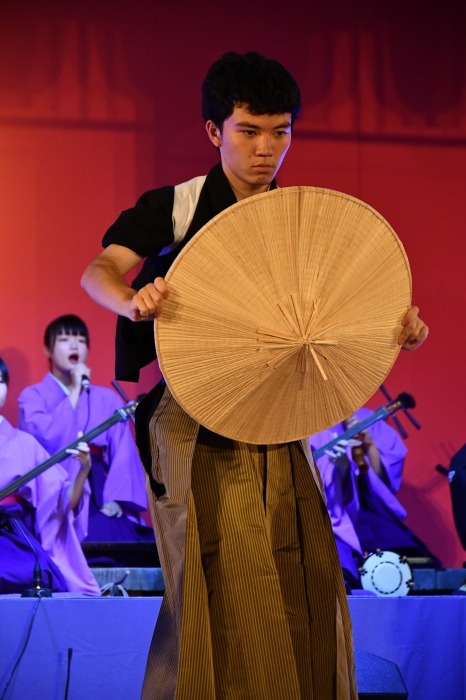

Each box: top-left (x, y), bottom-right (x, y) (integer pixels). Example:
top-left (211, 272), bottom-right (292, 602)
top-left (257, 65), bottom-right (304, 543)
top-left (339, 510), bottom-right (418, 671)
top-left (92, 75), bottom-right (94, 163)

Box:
top-left (0, 594), bottom-right (466, 700)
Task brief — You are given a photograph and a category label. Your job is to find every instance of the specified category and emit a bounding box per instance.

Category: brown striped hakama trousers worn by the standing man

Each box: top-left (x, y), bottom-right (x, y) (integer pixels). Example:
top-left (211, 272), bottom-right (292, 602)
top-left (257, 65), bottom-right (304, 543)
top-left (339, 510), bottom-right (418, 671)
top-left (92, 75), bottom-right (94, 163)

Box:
top-left (142, 390), bottom-right (357, 700)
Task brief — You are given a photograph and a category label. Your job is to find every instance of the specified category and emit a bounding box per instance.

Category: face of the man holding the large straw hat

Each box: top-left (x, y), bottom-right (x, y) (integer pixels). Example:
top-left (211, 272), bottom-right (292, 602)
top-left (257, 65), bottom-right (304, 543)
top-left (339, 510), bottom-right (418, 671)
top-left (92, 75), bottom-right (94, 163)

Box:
top-left (206, 106), bottom-right (291, 188)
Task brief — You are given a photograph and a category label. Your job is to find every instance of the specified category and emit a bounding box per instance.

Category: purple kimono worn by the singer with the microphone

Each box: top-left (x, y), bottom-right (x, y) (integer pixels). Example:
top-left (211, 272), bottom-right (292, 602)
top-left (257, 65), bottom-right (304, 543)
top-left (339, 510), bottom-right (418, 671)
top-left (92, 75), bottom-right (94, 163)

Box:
top-left (18, 373), bottom-right (153, 542)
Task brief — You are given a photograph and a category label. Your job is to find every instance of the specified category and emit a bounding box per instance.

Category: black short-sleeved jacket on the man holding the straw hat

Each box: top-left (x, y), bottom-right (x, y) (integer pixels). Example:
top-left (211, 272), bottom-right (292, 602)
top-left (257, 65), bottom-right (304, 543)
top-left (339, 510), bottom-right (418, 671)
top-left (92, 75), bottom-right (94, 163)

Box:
top-left (102, 163), bottom-right (277, 382)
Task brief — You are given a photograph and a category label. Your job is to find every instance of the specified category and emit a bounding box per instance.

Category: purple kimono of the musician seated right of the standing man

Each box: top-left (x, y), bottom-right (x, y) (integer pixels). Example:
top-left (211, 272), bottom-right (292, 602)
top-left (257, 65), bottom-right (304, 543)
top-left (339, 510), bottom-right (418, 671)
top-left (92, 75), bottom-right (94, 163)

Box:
top-left (308, 408), bottom-right (407, 580)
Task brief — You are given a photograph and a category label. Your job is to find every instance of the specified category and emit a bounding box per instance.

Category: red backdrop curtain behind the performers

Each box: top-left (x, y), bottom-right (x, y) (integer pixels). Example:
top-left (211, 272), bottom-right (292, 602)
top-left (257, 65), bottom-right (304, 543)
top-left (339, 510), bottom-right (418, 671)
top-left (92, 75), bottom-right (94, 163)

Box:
top-left (0, 0), bottom-right (466, 565)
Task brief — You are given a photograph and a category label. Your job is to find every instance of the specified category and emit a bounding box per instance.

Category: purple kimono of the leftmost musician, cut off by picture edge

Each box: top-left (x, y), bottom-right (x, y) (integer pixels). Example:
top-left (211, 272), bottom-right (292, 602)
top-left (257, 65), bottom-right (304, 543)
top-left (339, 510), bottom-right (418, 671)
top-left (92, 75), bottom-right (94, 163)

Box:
top-left (0, 418), bottom-right (100, 595)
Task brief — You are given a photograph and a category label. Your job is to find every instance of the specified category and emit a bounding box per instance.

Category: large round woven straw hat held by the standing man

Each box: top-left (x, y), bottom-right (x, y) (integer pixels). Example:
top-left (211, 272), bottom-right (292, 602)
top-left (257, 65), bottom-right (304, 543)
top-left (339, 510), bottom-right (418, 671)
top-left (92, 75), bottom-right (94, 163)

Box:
top-left (156, 187), bottom-right (411, 444)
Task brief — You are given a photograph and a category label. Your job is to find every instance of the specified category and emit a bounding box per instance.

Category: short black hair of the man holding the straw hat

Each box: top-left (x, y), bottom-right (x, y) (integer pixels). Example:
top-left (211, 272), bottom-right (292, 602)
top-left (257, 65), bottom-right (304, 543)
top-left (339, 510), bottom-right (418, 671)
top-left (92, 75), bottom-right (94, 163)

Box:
top-left (202, 51), bottom-right (301, 129)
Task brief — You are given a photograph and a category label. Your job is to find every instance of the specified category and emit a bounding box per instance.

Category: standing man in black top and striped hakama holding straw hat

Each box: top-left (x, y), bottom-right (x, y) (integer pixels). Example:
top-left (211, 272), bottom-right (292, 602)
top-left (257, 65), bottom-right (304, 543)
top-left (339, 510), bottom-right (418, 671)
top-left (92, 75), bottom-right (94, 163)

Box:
top-left (82, 52), bottom-right (427, 700)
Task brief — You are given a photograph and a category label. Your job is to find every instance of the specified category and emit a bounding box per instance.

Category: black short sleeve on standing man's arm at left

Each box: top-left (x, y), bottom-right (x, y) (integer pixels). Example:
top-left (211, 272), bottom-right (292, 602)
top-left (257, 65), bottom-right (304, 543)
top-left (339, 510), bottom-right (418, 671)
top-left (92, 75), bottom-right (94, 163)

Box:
top-left (102, 187), bottom-right (175, 258)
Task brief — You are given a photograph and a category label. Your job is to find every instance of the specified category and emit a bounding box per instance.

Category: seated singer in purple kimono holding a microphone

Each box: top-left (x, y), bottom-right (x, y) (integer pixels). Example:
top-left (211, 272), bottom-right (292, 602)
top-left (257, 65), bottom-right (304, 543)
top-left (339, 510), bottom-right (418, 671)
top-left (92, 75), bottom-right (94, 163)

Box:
top-left (18, 314), bottom-right (153, 552)
